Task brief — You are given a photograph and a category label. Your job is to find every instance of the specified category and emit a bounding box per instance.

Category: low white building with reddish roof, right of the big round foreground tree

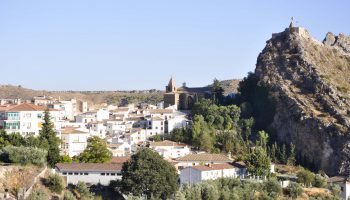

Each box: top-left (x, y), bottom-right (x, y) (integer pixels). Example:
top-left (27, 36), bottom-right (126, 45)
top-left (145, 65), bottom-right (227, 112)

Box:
top-left (180, 163), bottom-right (246, 185)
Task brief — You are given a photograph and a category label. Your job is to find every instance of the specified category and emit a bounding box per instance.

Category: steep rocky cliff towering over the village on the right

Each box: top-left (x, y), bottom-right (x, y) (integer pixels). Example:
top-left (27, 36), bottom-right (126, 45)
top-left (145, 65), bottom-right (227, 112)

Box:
top-left (255, 25), bottom-right (350, 175)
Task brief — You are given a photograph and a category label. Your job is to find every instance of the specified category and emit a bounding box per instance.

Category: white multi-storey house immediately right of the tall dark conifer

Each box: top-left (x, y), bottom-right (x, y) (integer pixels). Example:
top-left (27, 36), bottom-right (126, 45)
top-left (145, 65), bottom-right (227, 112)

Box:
top-left (61, 128), bottom-right (90, 157)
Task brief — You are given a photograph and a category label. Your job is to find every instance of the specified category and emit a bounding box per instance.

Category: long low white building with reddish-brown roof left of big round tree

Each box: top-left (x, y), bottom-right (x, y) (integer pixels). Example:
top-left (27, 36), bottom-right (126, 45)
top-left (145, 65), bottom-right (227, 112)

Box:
top-left (56, 163), bottom-right (122, 186)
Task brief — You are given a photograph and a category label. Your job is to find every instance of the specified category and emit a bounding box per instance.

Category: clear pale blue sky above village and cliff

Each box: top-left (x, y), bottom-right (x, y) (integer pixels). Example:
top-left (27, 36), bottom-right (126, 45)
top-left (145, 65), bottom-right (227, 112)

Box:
top-left (0, 0), bottom-right (350, 90)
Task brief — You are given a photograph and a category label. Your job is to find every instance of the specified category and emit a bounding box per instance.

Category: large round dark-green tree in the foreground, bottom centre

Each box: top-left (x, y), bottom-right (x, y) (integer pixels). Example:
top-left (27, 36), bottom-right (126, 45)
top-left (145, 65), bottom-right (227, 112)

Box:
top-left (121, 148), bottom-right (178, 199)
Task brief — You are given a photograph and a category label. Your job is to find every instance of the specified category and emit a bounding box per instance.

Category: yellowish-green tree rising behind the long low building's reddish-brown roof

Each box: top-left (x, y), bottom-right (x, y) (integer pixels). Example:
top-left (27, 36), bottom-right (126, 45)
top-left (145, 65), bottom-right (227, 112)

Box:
top-left (77, 136), bottom-right (113, 163)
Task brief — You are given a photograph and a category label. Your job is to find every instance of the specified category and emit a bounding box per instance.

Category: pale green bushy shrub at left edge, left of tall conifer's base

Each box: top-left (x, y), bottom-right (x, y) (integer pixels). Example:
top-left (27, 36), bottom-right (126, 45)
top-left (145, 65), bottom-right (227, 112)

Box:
top-left (0, 146), bottom-right (47, 166)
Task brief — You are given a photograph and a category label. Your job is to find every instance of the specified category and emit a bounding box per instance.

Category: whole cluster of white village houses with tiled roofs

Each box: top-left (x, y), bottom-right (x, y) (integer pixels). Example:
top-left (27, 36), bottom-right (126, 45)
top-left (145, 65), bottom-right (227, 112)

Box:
top-left (0, 96), bottom-right (350, 199)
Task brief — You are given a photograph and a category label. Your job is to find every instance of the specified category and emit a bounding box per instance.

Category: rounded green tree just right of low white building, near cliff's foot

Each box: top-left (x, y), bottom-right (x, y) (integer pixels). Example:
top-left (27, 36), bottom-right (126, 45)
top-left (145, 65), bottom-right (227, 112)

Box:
top-left (245, 147), bottom-right (270, 176)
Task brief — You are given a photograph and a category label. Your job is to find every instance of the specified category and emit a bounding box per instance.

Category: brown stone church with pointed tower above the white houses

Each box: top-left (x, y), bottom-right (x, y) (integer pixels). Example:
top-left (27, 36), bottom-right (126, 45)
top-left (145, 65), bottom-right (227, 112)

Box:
top-left (164, 77), bottom-right (211, 110)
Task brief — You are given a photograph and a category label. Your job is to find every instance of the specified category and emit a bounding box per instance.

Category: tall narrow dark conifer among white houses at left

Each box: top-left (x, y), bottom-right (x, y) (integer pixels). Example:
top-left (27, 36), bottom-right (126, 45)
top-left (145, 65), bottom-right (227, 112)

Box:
top-left (39, 110), bottom-right (60, 167)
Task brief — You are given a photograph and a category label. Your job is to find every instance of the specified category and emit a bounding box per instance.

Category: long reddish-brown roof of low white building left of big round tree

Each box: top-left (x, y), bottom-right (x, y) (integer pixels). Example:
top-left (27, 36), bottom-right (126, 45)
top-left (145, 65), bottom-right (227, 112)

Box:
top-left (56, 163), bottom-right (122, 172)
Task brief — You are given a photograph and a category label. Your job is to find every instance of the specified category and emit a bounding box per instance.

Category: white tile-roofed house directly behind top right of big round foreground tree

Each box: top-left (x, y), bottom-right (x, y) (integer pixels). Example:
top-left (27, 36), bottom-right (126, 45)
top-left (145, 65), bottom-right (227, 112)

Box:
top-left (149, 140), bottom-right (191, 159)
